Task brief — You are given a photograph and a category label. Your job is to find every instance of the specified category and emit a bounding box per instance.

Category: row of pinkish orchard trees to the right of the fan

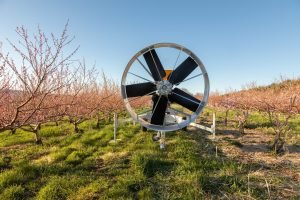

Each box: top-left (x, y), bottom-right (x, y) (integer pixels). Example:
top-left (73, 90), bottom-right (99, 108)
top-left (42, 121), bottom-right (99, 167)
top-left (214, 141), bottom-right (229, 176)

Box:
top-left (210, 80), bottom-right (300, 153)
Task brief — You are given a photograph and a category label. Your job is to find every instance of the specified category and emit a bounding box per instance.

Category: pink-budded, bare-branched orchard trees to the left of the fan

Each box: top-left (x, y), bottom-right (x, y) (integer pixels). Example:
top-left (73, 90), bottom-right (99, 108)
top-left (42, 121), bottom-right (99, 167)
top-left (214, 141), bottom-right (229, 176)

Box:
top-left (0, 24), bottom-right (123, 143)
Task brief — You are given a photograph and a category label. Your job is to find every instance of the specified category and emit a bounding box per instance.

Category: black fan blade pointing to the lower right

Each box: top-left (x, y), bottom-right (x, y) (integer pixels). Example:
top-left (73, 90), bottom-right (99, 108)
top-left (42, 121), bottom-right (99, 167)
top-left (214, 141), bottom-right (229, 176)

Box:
top-left (169, 88), bottom-right (201, 112)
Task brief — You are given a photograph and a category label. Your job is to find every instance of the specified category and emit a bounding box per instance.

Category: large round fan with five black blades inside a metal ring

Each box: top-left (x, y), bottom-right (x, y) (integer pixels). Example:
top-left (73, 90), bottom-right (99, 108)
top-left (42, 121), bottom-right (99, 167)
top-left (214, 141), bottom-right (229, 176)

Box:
top-left (121, 43), bottom-right (209, 132)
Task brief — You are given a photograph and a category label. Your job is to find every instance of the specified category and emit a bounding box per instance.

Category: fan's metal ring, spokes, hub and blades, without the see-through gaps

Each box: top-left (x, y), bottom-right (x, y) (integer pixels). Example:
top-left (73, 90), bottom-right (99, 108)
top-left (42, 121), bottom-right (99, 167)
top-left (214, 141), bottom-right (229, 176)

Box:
top-left (121, 43), bottom-right (209, 131)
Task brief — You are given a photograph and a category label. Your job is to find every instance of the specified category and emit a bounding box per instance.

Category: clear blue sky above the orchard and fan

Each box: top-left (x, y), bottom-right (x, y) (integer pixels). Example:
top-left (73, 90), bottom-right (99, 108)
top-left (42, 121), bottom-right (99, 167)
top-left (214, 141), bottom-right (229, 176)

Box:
top-left (0, 0), bottom-right (300, 91)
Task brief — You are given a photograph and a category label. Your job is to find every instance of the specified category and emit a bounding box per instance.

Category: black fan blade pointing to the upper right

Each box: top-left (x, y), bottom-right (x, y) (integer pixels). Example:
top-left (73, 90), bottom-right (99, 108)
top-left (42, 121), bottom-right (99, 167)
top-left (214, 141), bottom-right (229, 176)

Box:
top-left (169, 57), bottom-right (198, 84)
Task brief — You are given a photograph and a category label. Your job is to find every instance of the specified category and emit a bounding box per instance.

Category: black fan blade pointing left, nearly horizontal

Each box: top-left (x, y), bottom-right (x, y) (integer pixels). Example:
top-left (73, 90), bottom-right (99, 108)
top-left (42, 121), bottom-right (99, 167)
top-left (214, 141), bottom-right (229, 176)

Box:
top-left (126, 82), bottom-right (156, 97)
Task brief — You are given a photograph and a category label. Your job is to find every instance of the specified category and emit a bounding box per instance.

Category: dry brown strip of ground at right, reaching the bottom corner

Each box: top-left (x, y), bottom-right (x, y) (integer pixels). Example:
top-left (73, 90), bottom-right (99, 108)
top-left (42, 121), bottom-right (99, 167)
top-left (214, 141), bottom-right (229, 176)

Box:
top-left (209, 130), bottom-right (300, 199)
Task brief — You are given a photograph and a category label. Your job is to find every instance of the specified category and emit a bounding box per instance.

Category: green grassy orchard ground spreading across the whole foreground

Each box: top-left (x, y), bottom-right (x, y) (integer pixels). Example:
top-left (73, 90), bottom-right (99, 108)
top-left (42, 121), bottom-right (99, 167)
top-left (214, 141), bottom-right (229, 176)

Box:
top-left (0, 109), bottom-right (300, 200)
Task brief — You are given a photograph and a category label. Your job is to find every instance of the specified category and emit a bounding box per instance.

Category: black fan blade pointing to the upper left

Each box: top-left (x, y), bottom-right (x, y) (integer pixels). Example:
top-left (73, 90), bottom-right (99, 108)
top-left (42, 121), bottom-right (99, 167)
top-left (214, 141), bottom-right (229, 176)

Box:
top-left (143, 49), bottom-right (166, 81)
